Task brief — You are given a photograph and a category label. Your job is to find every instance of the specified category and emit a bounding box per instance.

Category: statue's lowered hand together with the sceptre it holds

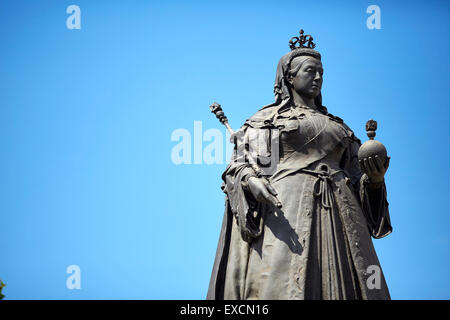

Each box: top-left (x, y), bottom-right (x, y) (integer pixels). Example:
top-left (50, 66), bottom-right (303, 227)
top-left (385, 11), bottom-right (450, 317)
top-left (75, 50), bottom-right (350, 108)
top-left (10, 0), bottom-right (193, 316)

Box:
top-left (209, 102), bottom-right (282, 208)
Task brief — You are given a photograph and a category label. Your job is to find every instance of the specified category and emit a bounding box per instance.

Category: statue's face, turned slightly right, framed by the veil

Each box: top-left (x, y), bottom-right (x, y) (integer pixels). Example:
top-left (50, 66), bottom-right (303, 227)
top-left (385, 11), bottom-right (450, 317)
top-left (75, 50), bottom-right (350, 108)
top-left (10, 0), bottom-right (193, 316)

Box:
top-left (288, 56), bottom-right (323, 99)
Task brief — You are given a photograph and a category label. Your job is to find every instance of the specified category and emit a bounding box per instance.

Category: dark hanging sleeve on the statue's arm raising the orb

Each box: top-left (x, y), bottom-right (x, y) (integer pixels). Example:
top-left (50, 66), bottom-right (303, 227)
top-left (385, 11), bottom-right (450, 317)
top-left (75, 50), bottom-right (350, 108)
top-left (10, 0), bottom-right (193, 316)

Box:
top-left (343, 138), bottom-right (392, 239)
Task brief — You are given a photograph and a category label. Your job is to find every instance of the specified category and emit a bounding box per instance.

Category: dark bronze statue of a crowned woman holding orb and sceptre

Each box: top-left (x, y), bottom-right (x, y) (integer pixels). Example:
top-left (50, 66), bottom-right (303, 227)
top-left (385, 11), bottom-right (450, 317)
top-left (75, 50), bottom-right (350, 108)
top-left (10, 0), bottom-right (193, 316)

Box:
top-left (207, 30), bottom-right (392, 299)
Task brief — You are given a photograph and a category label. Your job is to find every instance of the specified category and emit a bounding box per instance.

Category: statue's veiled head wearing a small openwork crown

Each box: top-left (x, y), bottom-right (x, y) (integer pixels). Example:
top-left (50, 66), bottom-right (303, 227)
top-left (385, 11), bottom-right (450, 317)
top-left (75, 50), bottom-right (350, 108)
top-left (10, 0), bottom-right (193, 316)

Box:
top-left (274, 30), bottom-right (323, 107)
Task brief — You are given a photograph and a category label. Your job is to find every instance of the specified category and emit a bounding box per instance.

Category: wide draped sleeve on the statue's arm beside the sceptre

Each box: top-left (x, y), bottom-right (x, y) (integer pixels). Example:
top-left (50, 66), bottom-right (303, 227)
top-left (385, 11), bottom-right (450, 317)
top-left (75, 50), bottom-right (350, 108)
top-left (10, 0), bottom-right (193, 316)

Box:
top-left (222, 125), bottom-right (268, 242)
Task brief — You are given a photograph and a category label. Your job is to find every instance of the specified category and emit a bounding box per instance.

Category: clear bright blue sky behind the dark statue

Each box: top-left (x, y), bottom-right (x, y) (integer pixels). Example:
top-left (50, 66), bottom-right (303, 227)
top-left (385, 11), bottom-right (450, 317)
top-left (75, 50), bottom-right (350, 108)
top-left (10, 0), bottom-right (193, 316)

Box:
top-left (0, 0), bottom-right (450, 299)
